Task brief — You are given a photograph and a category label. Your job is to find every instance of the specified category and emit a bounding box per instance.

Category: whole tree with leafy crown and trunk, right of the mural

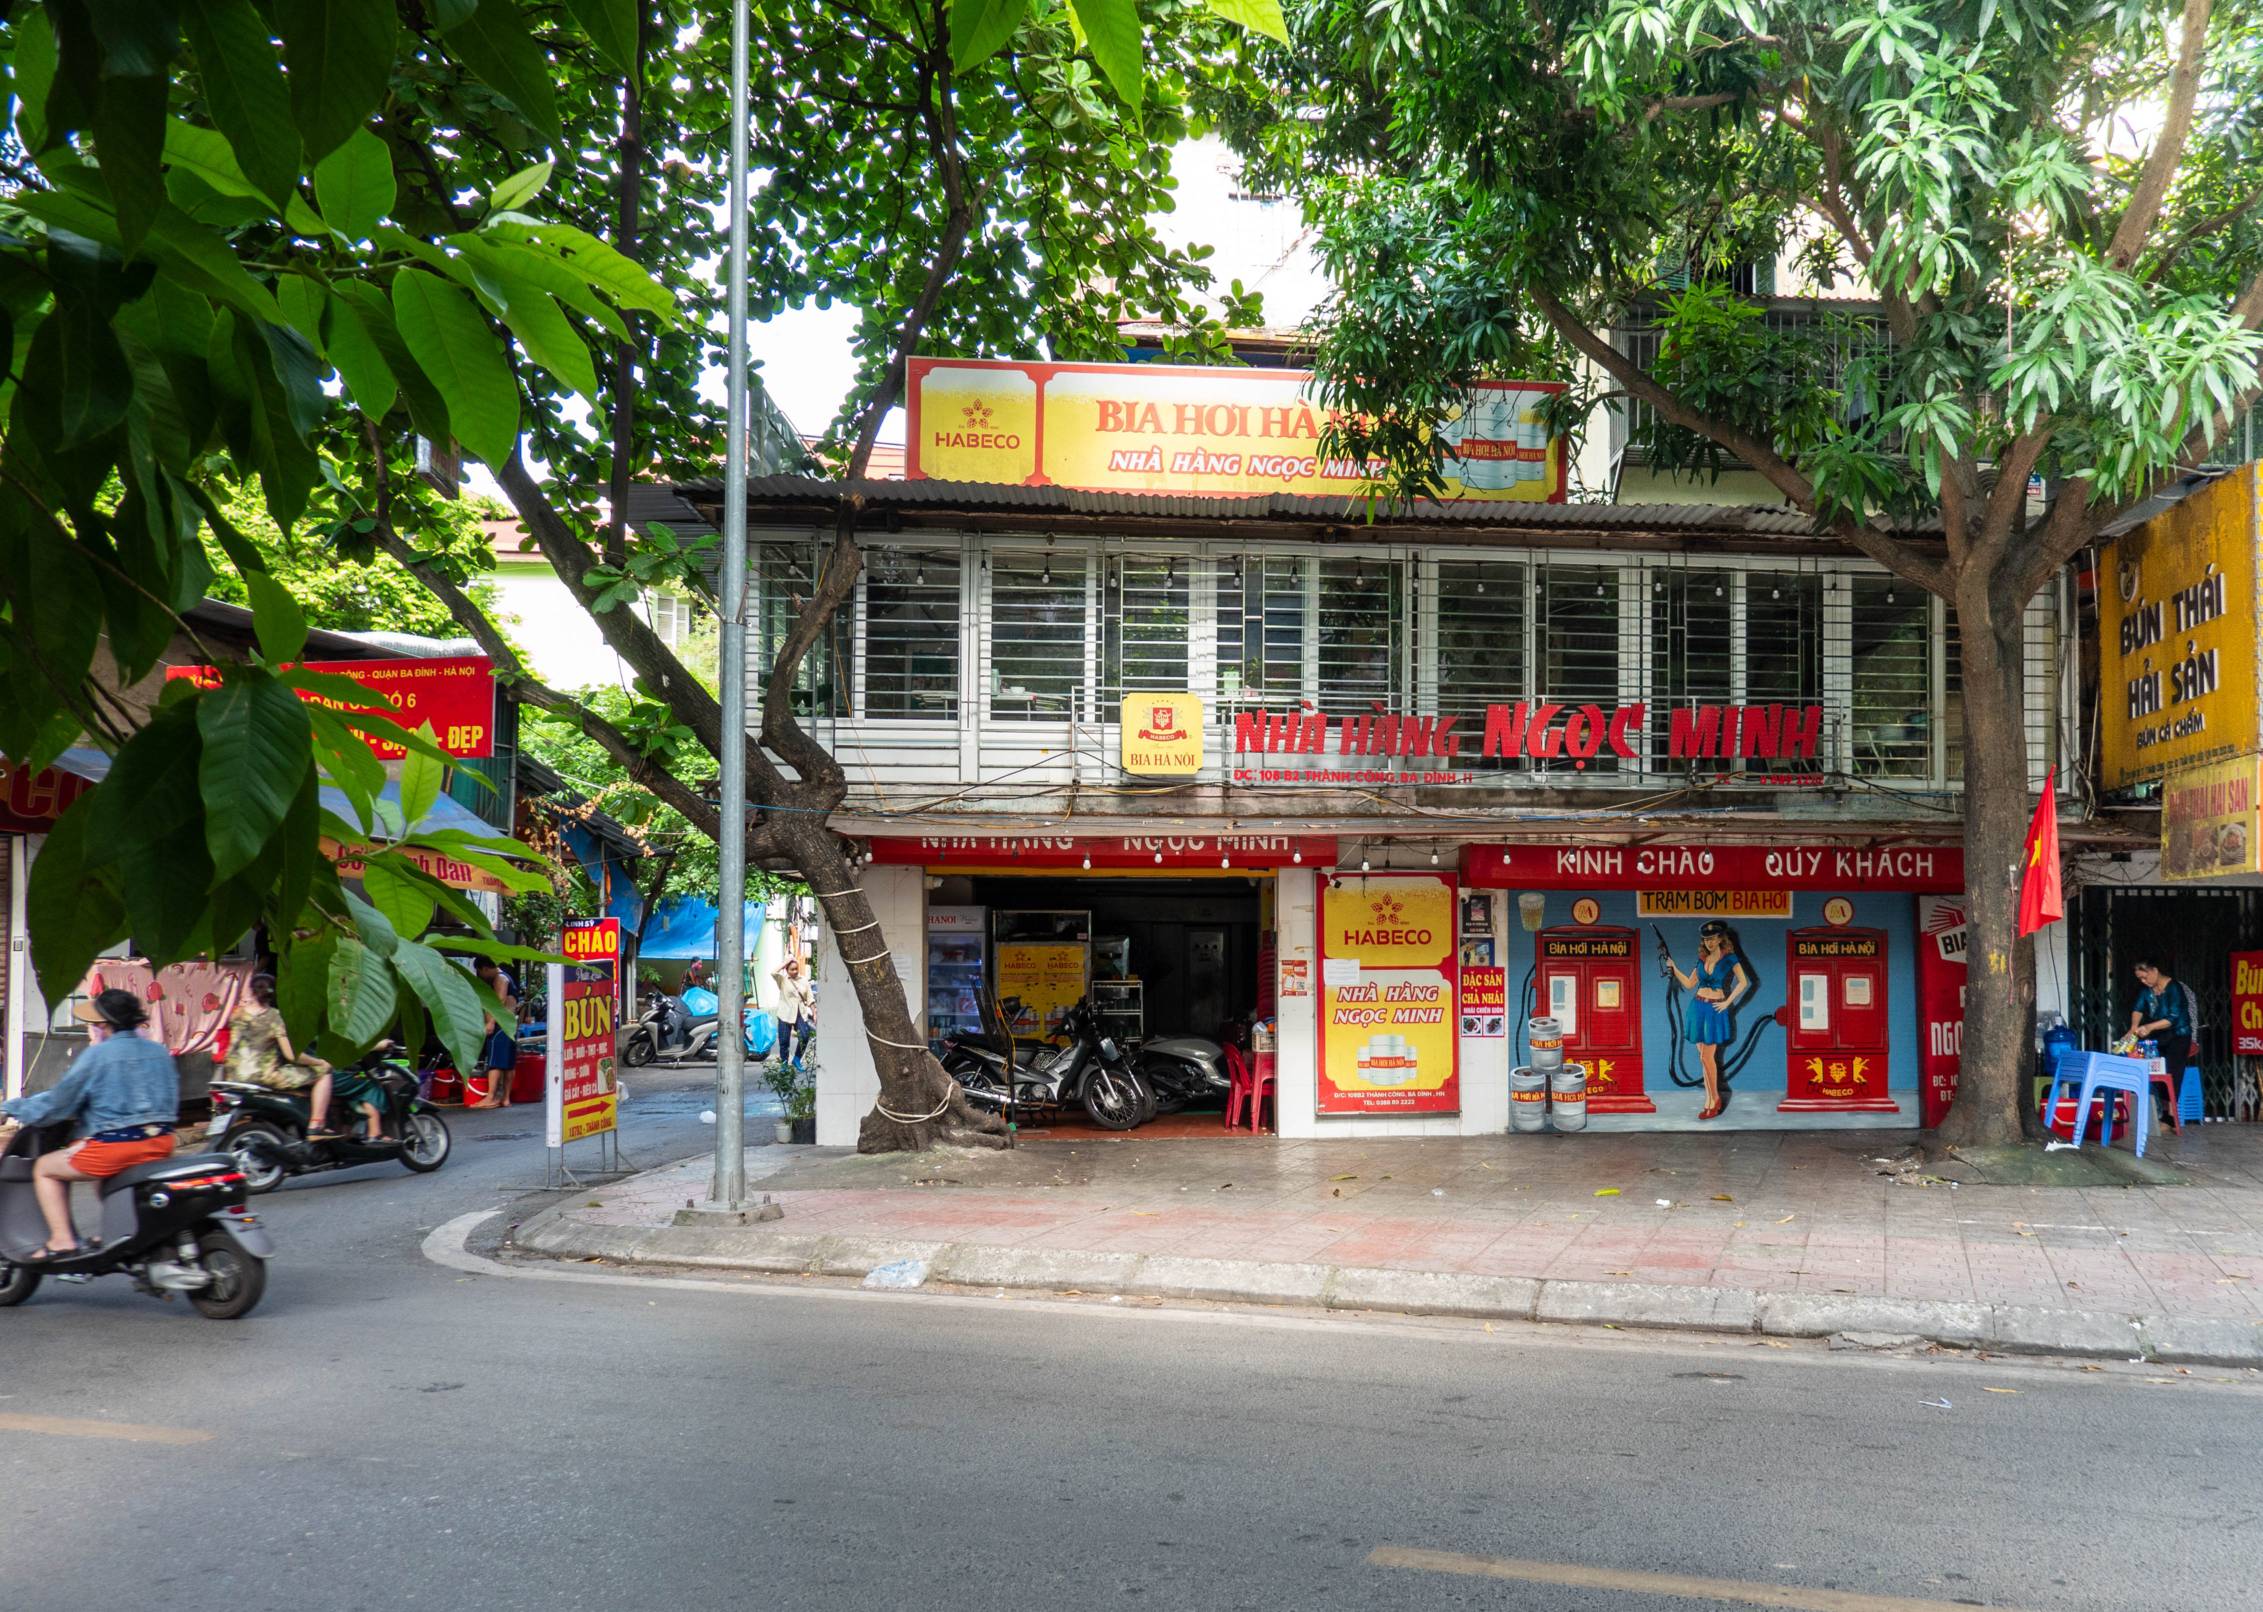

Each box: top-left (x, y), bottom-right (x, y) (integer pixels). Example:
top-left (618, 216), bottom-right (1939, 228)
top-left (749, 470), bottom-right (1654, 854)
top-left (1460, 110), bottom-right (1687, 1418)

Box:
top-left (1238, 0), bottom-right (2263, 1139)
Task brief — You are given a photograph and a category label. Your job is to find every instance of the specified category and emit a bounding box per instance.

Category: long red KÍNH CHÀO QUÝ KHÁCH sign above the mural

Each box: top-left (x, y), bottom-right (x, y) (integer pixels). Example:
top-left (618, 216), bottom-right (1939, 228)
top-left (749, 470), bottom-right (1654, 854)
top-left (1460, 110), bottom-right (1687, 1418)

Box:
top-left (1462, 844), bottom-right (1964, 892)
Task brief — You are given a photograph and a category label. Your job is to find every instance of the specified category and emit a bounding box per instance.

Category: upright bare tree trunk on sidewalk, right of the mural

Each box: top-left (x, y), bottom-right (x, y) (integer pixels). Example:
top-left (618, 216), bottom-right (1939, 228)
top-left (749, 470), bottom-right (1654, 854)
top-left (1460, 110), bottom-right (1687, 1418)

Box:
top-left (1939, 571), bottom-right (2034, 1148)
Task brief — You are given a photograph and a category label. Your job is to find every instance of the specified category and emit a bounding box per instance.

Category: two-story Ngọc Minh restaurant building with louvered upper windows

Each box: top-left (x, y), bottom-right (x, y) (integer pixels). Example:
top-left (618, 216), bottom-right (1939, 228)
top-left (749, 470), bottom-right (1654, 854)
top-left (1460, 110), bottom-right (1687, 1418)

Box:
top-left (679, 362), bottom-right (2073, 1143)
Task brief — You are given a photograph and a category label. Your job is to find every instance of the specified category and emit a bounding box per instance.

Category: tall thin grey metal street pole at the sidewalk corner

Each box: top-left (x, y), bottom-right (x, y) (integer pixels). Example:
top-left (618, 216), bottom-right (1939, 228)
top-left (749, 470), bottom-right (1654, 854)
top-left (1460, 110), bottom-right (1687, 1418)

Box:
top-left (708, 0), bottom-right (747, 1209)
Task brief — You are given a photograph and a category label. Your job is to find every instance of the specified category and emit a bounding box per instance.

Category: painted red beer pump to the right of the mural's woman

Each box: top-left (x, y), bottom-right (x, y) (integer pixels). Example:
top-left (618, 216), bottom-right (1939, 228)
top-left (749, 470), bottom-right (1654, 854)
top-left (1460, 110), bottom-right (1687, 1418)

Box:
top-left (1776, 928), bottom-right (1901, 1114)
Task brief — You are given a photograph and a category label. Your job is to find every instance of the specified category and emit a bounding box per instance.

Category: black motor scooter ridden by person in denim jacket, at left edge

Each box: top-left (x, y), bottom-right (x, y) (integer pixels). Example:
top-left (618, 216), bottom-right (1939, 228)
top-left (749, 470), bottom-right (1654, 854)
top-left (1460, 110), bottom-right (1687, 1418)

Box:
top-left (0, 1125), bottom-right (274, 1320)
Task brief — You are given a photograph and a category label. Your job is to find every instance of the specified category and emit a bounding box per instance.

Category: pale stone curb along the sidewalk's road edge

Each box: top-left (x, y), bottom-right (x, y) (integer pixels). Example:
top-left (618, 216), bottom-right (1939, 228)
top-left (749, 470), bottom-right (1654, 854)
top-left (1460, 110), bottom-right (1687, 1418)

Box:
top-left (511, 1209), bottom-right (2263, 1367)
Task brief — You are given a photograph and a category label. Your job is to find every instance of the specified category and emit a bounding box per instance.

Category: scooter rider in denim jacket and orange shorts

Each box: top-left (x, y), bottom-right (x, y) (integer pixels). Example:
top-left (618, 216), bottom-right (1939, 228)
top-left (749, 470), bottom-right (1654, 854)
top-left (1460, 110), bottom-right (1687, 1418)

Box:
top-left (0, 989), bottom-right (181, 1266)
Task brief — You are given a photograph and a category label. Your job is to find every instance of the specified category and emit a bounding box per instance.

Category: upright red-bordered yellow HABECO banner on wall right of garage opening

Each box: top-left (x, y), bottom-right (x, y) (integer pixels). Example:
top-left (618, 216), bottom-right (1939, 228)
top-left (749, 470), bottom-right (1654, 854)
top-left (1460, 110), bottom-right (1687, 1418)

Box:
top-left (1319, 874), bottom-right (1462, 1114)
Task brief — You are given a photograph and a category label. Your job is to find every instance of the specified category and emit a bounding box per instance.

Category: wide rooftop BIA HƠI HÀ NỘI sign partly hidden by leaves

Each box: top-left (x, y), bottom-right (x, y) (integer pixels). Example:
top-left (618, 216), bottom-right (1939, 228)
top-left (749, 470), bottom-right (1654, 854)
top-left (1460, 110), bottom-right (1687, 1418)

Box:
top-left (905, 358), bottom-right (1566, 503)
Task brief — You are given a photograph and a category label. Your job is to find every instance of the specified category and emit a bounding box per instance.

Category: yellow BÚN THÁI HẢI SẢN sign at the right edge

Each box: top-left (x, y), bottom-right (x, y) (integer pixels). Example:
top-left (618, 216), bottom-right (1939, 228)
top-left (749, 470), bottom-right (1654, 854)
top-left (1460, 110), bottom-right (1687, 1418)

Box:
top-left (2098, 464), bottom-right (2263, 790)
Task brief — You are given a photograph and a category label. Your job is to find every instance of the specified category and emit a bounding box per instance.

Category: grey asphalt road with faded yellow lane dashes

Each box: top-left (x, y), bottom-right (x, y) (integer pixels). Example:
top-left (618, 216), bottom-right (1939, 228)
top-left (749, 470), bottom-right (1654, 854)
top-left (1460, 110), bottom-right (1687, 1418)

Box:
top-left (0, 1073), bottom-right (2263, 1612)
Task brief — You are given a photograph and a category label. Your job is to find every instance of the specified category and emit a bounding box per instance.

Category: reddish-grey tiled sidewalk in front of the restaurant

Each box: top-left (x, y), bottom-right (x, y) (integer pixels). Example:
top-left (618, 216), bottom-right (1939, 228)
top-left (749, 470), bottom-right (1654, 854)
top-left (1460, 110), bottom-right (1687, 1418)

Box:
top-left (552, 1125), bottom-right (2263, 1327)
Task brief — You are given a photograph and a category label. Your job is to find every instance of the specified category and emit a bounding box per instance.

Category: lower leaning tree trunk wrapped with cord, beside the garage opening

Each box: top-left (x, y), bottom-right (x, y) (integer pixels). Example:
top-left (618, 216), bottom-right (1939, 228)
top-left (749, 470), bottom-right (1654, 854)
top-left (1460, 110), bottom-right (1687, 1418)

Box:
top-left (776, 813), bottom-right (1007, 1152)
